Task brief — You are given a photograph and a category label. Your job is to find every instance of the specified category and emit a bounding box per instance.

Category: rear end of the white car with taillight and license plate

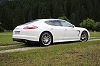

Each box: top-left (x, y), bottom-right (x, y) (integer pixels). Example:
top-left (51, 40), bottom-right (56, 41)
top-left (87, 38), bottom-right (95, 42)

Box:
top-left (12, 19), bottom-right (41, 42)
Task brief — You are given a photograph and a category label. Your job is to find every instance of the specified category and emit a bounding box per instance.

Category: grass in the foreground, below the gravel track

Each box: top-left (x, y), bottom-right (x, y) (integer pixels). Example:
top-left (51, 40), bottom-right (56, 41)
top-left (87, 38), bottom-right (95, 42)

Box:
top-left (0, 41), bottom-right (100, 66)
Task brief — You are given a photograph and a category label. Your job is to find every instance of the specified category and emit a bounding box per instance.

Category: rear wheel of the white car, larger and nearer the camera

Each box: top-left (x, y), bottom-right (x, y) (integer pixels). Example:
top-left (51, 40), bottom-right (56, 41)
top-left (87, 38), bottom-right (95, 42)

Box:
top-left (39, 32), bottom-right (53, 46)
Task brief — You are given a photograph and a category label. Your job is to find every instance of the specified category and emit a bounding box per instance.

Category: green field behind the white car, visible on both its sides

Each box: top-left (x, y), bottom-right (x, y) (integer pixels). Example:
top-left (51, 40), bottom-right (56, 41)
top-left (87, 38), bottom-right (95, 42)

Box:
top-left (0, 32), bottom-right (100, 46)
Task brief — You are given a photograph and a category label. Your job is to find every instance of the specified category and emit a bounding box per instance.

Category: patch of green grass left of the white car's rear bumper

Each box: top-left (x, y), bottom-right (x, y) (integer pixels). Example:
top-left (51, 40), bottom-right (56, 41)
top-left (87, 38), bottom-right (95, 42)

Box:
top-left (0, 32), bottom-right (18, 46)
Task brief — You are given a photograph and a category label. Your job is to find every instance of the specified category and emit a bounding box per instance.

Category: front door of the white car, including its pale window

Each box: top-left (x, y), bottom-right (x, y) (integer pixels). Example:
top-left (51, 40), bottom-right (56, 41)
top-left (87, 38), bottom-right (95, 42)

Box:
top-left (61, 21), bottom-right (80, 40)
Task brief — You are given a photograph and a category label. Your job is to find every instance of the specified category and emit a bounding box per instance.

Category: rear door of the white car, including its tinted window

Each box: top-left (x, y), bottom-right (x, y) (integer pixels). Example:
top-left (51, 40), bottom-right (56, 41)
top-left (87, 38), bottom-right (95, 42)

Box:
top-left (45, 20), bottom-right (65, 42)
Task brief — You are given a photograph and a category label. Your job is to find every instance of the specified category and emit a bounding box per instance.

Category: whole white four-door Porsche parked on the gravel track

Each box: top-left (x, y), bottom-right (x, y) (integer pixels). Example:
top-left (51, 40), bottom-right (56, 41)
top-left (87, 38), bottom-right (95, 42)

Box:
top-left (12, 19), bottom-right (90, 46)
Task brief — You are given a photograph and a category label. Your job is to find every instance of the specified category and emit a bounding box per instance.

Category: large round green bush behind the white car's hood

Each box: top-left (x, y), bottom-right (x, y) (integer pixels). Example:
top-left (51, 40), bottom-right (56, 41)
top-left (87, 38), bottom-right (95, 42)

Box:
top-left (80, 18), bottom-right (96, 30)
